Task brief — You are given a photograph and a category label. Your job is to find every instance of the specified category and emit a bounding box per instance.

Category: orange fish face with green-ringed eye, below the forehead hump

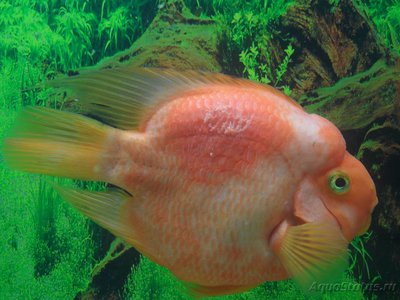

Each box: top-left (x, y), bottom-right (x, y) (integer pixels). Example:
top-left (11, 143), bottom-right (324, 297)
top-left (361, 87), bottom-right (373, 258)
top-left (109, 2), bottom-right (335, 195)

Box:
top-left (294, 152), bottom-right (378, 241)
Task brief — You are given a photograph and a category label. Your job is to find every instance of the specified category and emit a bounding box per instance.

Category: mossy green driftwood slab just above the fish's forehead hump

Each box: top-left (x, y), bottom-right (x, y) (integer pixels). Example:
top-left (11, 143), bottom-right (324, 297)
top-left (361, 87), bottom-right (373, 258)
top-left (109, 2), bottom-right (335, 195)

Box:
top-left (304, 60), bottom-right (400, 131)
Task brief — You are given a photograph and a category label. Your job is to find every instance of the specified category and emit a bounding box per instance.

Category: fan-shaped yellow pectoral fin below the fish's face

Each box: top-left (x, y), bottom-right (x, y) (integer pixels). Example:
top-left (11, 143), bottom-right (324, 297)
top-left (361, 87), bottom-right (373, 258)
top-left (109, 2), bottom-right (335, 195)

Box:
top-left (278, 223), bottom-right (348, 291)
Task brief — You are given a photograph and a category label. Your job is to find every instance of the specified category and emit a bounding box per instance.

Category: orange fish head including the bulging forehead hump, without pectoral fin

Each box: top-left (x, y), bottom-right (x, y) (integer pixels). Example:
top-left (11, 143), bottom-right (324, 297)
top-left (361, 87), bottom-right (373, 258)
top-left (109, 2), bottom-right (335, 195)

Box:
top-left (293, 115), bottom-right (378, 241)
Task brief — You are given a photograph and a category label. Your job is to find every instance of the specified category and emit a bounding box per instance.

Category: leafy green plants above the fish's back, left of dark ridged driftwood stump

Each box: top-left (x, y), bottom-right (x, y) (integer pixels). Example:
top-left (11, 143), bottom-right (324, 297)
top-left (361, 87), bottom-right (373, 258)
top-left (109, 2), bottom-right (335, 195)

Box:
top-left (215, 0), bottom-right (294, 94)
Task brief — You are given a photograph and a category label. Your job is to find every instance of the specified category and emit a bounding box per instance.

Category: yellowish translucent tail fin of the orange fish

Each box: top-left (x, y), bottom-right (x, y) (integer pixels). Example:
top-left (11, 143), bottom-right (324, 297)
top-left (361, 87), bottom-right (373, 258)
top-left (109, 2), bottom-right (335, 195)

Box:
top-left (3, 107), bottom-right (111, 180)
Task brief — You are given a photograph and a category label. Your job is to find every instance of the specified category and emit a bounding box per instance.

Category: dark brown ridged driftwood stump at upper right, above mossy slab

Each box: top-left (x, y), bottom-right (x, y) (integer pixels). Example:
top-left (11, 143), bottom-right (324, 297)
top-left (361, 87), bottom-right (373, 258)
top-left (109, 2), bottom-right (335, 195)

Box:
top-left (269, 0), bottom-right (387, 98)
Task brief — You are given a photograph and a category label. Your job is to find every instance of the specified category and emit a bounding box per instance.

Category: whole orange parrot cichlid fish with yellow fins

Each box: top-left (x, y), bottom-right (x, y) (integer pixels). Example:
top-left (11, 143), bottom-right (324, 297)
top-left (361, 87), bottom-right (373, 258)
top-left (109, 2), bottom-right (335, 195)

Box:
top-left (4, 68), bottom-right (377, 295)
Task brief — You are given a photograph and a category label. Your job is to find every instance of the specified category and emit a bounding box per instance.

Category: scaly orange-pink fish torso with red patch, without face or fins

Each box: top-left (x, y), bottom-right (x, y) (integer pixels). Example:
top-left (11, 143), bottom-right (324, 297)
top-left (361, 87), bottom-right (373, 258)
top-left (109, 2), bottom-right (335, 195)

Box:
top-left (100, 86), bottom-right (338, 285)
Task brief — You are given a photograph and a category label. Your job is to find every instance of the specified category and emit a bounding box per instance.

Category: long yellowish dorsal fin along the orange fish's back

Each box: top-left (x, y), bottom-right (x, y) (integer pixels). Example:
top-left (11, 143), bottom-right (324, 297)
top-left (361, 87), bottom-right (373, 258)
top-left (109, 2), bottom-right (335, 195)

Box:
top-left (48, 67), bottom-right (298, 130)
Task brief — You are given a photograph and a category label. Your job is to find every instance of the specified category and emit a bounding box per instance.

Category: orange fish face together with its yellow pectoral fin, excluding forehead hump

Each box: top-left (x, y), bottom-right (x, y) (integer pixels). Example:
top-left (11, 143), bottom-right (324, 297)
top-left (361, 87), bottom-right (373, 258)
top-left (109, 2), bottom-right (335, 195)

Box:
top-left (269, 152), bottom-right (378, 290)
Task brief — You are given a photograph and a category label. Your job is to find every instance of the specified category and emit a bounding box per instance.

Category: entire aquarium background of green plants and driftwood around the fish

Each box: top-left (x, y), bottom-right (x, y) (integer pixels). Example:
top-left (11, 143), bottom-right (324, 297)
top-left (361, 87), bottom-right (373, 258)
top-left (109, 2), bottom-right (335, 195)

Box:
top-left (0, 0), bottom-right (400, 299)
